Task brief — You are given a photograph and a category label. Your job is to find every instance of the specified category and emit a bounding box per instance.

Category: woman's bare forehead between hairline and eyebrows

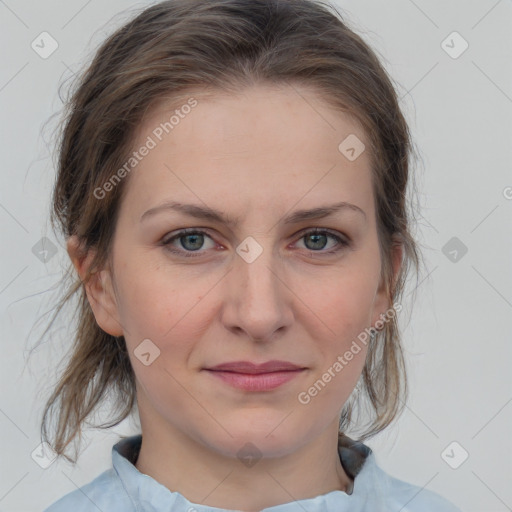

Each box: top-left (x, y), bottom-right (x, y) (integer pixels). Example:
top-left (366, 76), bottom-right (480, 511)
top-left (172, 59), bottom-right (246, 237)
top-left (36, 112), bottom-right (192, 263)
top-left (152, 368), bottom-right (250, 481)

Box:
top-left (120, 85), bottom-right (372, 224)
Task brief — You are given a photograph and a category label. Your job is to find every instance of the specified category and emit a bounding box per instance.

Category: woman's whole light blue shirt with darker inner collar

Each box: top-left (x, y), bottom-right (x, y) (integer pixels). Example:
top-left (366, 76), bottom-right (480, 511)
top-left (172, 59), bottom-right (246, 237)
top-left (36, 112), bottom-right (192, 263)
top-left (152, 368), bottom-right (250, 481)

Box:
top-left (44, 434), bottom-right (461, 512)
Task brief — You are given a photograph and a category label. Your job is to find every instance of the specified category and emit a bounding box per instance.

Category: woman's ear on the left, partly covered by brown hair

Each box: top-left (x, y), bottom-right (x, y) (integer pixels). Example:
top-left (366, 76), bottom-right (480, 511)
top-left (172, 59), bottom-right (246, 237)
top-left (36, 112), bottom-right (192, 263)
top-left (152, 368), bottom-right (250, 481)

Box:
top-left (66, 235), bottom-right (123, 336)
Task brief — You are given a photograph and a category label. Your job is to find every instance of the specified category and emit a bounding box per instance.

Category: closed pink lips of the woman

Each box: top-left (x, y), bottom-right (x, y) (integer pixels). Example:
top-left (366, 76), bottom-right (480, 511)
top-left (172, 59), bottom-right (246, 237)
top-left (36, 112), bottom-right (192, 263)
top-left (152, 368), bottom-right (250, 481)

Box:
top-left (206, 361), bottom-right (305, 391)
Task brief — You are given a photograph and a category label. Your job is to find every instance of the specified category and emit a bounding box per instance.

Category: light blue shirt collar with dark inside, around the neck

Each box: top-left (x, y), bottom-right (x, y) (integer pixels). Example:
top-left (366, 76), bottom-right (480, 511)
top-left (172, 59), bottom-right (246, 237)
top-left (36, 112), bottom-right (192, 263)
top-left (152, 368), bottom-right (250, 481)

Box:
top-left (112, 433), bottom-right (374, 512)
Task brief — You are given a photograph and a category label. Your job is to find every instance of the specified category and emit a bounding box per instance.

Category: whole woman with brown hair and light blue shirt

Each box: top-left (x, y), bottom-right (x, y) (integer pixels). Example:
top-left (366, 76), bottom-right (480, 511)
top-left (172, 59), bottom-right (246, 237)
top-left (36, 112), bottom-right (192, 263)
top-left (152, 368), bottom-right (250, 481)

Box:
top-left (42, 0), bottom-right (457, 512)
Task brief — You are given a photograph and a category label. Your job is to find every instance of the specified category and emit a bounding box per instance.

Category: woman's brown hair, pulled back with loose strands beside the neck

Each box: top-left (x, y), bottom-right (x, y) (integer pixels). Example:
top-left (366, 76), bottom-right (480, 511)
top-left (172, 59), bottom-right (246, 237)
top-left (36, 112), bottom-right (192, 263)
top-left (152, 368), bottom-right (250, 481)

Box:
top-left (41, 0), bottom-right (421, 462)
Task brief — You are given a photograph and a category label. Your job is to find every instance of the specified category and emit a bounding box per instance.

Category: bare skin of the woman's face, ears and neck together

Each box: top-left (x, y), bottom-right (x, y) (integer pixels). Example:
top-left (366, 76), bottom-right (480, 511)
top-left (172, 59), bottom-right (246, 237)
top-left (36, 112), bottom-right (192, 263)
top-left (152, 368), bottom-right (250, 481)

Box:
top-left (68, 85), bottom-right (402, 511)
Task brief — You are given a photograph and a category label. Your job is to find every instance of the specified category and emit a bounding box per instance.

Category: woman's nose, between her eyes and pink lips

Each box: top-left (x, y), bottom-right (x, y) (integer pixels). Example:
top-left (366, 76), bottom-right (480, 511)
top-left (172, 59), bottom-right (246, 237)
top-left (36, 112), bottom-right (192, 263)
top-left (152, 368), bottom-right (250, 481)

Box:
top-left (222, 244), bottom-right (294, 342)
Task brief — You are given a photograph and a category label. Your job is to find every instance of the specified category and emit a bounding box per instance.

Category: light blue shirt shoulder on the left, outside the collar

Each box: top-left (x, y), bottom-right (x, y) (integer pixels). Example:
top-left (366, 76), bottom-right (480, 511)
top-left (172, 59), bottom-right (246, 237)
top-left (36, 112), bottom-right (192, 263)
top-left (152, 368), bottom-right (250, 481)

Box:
top-left (43, 469), bottom-right (133, 512)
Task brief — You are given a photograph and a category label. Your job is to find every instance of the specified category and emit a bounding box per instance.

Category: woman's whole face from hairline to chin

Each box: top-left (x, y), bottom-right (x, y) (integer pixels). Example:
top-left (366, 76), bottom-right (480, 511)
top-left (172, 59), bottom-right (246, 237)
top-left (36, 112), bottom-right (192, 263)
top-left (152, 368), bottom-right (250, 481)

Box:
top-left (75, 86), bottom-right (400, 456)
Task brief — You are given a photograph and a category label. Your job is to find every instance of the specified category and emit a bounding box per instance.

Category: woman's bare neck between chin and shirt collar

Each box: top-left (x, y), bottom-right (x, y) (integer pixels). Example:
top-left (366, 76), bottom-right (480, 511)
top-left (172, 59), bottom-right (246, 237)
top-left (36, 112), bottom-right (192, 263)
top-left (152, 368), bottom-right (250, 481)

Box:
top-left (135, 416), bottom-right (353, 512)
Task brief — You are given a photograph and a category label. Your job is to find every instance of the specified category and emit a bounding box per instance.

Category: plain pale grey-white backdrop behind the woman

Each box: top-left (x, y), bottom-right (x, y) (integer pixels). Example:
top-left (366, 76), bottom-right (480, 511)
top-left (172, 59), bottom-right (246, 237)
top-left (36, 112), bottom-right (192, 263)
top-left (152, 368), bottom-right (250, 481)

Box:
top-left (0, 0), bottom-right (512, 512)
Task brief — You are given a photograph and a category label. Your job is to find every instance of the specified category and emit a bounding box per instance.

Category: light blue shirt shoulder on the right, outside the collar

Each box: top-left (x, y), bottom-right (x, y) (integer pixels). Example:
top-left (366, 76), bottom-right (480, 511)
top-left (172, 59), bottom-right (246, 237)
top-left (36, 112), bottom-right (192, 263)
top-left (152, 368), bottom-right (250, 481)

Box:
top-left (368, 453), bottom-right (461, 512)
